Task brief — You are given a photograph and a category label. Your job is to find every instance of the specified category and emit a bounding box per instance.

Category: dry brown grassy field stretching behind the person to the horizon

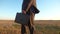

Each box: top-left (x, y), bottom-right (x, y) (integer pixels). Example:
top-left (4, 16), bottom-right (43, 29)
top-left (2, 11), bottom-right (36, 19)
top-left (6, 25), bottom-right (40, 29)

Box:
top-left (0, 20), bottom-right (60, 34)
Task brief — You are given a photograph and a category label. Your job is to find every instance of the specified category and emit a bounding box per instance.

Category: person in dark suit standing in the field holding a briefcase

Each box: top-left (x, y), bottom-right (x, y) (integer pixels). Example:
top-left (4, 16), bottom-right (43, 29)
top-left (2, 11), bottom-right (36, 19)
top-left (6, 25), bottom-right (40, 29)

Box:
top-left (21, 0), bottom-right (36, 34)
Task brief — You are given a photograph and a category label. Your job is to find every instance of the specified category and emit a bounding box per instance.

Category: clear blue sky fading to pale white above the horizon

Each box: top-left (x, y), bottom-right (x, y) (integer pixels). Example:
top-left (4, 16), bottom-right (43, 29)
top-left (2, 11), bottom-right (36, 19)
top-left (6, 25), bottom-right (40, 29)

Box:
top-left (0, 0), bottom-right (60, 20)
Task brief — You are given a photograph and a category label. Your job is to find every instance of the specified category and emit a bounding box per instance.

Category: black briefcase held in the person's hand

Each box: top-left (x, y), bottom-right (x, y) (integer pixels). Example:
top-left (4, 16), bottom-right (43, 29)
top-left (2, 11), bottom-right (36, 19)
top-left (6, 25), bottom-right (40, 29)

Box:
top-left (15, 13), bottom-right (30, 25)
